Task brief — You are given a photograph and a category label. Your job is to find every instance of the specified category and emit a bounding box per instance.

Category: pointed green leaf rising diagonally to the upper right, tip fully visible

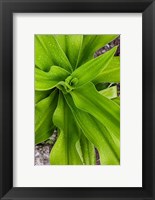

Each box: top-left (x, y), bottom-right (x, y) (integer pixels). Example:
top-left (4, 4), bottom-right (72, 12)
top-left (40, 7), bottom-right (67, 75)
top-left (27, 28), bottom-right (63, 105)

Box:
top-left (71, 47), bottom-right (117, 87)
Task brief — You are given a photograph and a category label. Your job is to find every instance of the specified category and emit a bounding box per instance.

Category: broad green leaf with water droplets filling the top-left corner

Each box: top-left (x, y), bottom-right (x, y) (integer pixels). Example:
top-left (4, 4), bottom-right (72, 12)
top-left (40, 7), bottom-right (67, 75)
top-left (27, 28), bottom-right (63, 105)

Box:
top-left (35, 35), bottom-right (72, 72)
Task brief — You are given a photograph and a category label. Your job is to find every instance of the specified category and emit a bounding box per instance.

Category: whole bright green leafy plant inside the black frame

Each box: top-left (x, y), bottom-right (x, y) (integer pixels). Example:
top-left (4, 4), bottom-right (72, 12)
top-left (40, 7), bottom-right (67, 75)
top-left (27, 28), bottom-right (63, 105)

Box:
top-left (35, 35), bottom-right (120, 165)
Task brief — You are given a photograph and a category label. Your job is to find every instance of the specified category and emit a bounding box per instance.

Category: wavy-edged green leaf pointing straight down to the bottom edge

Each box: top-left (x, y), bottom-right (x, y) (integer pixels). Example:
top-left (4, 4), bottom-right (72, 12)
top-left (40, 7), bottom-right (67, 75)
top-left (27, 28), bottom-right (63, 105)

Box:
top-left (50, 93), bottom-right (82, 165)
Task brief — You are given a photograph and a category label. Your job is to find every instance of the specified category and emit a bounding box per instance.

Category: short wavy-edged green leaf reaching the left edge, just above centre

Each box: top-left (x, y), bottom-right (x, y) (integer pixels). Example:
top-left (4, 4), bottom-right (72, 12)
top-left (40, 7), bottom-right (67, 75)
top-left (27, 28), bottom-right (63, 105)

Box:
top-left (35, 66), bottom-right (69, 91)
